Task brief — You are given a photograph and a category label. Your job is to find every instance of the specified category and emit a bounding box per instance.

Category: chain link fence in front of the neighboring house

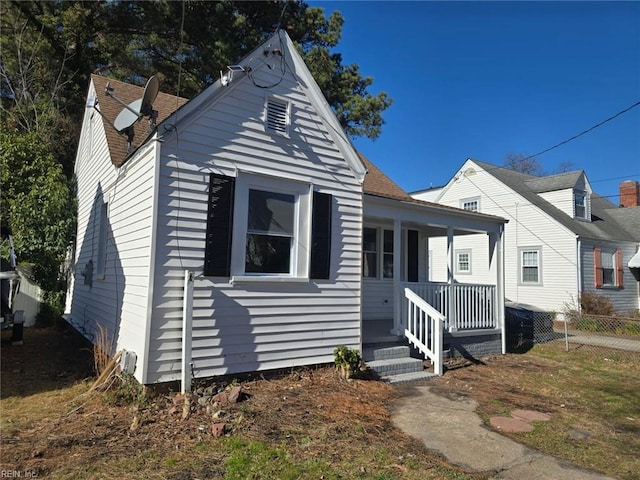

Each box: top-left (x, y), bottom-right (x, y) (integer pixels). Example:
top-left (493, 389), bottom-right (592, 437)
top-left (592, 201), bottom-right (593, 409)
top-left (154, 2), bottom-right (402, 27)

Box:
top-left (506, 310), bottom-right (640, 362)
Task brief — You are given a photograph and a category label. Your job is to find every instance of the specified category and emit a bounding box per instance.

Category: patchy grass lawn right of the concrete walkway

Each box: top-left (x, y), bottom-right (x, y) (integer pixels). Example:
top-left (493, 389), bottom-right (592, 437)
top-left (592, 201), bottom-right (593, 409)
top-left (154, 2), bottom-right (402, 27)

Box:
top-left (434, 343), bottom-right (640, 480)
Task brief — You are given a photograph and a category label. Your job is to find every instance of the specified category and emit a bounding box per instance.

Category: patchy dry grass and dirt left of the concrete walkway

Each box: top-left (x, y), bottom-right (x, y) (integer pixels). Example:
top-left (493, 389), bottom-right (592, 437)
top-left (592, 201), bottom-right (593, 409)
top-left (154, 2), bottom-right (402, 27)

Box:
top-left (0, 328), bottom-right (480, 480)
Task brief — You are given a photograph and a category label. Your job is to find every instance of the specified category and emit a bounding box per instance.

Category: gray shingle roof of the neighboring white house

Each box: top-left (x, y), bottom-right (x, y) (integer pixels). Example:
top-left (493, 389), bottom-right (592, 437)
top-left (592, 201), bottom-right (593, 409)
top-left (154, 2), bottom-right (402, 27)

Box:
top-left (472, 159), bottom-right (640, 242)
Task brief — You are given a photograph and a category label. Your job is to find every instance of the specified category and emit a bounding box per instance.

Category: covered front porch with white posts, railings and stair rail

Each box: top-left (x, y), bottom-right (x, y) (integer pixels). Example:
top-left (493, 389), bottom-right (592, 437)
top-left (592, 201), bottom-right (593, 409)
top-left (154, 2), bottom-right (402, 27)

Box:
top-left (362, 191), bottom-right (504, 374)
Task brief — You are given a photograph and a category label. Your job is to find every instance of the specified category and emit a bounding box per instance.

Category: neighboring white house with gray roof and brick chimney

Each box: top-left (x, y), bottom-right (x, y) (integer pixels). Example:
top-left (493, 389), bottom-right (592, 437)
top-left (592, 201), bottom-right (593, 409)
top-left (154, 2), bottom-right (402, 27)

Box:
top-left (413, 159), bottom-right (640, 313)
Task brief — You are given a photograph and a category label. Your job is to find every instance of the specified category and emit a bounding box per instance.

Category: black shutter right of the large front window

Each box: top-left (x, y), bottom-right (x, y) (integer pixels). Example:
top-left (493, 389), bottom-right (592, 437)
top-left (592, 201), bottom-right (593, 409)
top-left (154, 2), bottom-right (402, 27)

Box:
top-left (309, 192), bottom-right (333, 279)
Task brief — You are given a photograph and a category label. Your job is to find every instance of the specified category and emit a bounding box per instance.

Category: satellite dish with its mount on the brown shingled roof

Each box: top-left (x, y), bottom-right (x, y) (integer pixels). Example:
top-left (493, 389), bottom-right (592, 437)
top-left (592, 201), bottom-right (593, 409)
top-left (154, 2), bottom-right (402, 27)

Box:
top-left (104, 76), bottom-right (160, 151)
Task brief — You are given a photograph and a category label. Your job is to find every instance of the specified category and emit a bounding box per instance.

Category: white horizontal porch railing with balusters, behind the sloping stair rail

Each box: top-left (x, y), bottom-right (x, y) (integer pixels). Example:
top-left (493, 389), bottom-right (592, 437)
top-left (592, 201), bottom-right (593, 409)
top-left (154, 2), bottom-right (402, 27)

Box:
top-left (402, 282), bottom-right (498, 331)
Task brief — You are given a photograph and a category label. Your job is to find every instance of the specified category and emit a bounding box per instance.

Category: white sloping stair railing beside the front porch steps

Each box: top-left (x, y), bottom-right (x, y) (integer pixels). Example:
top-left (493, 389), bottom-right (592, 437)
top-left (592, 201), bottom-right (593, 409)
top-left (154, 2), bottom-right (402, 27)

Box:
top-left (404, 288), bottom-right (444, 375)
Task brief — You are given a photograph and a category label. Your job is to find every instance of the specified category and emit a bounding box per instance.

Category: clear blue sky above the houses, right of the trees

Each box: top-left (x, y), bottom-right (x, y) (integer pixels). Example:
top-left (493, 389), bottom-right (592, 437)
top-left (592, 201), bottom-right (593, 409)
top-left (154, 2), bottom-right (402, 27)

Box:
top-left (309, 1), bottom-right (640, 204)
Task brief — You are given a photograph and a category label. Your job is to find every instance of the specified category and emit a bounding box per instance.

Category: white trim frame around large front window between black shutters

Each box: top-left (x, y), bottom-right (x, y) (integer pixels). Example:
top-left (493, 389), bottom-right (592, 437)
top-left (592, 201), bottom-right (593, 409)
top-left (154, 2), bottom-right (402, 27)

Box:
top-left (230, 172), bottom-right (313, 282)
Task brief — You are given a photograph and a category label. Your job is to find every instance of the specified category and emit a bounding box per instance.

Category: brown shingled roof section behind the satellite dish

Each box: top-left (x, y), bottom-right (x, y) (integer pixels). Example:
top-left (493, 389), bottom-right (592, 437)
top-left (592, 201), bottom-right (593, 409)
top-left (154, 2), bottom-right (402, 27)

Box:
top-left (91, 74), bottom-right (187, 167)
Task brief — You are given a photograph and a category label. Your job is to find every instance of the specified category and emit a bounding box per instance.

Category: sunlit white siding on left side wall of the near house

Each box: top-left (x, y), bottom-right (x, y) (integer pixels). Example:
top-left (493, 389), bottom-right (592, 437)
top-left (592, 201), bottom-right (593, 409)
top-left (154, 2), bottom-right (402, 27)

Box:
top-left (65, 79), bottom-right (156, 381)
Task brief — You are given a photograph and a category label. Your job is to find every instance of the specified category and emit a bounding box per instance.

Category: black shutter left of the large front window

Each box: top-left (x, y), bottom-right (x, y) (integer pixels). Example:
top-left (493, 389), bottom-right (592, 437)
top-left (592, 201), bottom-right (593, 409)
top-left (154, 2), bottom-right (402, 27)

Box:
top-left (204, 173), bottom-right (236, 277)
